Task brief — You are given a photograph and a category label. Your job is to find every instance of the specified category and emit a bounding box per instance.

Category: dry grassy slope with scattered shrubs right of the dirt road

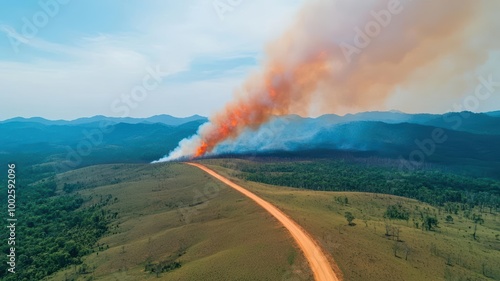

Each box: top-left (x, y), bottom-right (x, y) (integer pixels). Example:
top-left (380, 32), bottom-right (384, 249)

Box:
top-left (205, 160), bottom-right (500, 280)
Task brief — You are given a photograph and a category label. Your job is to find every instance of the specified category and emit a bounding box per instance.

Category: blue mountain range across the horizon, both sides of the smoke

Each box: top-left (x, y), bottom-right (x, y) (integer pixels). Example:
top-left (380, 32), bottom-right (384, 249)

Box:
top-left (0, 111), bottom-right (500, 176)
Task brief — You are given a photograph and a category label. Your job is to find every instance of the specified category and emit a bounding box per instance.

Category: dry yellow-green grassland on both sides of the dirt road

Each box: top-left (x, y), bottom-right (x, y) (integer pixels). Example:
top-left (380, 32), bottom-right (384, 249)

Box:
top-left (49, 159), bottom-right (500, 281)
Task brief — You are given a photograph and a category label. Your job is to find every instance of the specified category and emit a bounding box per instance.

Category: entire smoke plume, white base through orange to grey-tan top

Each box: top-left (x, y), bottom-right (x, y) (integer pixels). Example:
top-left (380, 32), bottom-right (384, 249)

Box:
top-left (156, 0), bottom-right (500, 161)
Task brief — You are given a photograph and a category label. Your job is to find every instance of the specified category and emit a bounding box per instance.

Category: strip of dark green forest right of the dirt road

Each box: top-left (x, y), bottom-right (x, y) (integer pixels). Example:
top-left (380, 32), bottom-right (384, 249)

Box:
top-left (222, 159), bottom-right (500, 211)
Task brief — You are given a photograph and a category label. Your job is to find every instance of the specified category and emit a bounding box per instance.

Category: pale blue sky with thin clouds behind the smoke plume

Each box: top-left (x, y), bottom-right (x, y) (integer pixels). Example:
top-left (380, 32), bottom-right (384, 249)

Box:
top-left (0, 0), bottom-right (500, 120)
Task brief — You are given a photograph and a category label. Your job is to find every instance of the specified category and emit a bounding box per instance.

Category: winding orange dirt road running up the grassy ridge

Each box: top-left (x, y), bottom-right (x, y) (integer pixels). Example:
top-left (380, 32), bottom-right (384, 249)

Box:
top-left (186, 163), bottom-right (341, 281)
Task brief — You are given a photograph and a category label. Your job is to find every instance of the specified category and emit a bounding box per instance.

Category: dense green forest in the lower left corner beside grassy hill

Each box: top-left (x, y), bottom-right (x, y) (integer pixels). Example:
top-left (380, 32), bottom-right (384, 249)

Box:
top-left (0, 167), bottom-right (109, 281)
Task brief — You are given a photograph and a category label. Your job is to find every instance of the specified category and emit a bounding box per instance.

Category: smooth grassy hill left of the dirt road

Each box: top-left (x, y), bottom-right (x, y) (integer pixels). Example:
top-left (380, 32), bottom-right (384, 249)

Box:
top-left (49, 164), bottom-right (311, 280)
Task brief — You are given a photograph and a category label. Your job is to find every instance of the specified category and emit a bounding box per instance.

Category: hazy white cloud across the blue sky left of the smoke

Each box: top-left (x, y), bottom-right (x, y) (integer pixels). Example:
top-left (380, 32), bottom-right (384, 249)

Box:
top-left (0, 0), bottom-right (299, 119)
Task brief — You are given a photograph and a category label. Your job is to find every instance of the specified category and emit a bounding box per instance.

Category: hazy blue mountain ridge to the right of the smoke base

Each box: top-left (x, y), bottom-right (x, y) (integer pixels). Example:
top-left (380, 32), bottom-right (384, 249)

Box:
top-left (215, 112), bottom-right (500, 177)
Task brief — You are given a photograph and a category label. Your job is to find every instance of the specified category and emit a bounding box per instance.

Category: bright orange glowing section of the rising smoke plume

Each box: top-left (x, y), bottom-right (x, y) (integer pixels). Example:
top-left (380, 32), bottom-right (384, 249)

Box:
top-left (194, 52), bottom-right (328, 157)
